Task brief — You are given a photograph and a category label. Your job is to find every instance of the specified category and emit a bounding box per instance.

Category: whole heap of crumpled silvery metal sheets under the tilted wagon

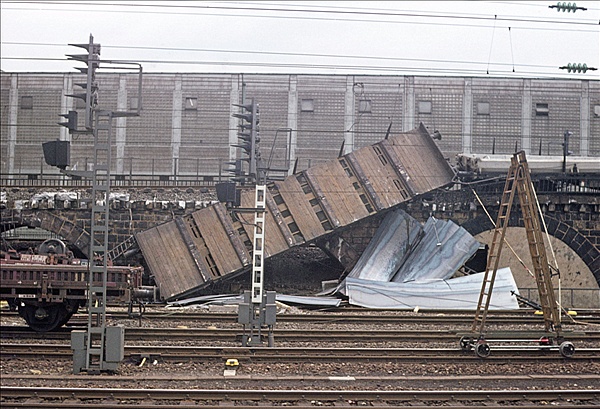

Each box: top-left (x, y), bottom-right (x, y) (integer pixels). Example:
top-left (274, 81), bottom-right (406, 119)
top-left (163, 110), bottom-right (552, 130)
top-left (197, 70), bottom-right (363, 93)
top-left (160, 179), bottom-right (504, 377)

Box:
top-left (334, 210), bottom-right (519, 309)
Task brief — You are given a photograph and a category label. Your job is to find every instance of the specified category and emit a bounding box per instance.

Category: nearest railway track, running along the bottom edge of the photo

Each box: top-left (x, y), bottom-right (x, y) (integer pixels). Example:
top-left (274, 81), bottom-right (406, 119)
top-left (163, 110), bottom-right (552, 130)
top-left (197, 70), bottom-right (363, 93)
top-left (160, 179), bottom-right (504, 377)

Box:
top-left (2, 387), bottom-right (600, 409)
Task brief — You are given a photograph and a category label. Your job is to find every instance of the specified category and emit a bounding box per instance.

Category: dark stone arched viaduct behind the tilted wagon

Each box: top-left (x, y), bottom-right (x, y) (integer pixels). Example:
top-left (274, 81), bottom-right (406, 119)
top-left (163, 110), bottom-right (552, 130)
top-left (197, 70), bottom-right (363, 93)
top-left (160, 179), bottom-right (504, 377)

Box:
top-left (0, 174), bottom-right (600, 292)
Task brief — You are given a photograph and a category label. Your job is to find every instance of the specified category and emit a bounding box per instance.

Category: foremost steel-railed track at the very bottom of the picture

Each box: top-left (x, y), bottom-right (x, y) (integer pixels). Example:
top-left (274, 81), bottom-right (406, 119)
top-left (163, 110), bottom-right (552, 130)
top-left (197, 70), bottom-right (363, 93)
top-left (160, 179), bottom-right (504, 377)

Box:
top-left (2, 386), bottom-right (600, 408)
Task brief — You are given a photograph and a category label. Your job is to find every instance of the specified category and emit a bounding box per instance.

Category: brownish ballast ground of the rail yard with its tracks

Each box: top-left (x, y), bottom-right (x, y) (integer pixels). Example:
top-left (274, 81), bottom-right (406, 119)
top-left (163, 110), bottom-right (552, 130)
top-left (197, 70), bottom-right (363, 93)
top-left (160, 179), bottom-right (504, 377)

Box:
top-left (0, 307), bottom-right (600, 407)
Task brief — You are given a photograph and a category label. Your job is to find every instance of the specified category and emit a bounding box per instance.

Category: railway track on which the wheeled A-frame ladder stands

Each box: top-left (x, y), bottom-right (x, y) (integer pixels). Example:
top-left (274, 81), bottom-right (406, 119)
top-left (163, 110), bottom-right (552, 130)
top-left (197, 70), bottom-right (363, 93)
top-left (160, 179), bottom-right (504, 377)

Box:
top-left (0, 344), bottom-right (600, 364)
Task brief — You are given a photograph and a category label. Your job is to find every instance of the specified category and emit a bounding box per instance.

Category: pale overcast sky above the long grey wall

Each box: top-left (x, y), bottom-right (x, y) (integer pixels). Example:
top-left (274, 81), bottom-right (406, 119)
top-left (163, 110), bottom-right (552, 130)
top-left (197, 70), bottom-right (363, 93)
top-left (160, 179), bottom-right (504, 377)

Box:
top-left (1, 0), bottom-right (600, 79)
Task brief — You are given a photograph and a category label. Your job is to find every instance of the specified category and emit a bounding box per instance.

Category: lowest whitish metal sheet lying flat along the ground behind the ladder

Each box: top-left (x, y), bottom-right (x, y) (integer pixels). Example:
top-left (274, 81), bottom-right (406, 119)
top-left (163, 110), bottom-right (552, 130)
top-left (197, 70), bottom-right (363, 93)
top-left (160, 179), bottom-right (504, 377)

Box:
top-left (344, 267), bottom-right (519, 309)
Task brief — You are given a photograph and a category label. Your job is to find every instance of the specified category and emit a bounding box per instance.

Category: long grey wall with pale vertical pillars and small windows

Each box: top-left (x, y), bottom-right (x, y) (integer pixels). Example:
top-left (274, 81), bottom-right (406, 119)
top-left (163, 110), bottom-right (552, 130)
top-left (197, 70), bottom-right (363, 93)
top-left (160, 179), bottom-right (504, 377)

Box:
top-left (0, 73), bottom-right (600, 175)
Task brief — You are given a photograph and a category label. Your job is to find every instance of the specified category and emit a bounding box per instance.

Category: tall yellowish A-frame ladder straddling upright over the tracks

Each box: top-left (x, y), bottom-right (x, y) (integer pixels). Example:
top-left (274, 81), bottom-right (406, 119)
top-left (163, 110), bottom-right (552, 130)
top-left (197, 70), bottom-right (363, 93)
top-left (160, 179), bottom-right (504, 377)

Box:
top-left (471, 151), bottom-right (562, 339)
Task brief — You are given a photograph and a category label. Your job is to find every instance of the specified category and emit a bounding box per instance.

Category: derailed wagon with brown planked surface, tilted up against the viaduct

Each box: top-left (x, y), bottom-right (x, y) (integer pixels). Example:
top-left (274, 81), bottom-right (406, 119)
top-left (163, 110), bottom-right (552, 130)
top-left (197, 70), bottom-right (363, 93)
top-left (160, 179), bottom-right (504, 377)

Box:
top-left (136, 124), bottom-right (454, 299)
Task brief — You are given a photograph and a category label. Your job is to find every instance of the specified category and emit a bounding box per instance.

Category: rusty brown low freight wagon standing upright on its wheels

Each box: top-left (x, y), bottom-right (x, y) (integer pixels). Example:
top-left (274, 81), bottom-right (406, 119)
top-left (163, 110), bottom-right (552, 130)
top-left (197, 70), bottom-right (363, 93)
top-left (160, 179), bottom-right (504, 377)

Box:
top-left (0, 239), bottom-right (152, 332)
